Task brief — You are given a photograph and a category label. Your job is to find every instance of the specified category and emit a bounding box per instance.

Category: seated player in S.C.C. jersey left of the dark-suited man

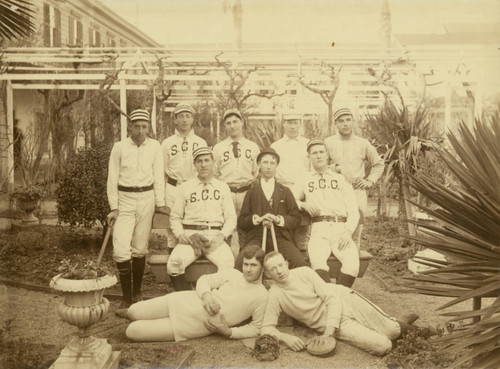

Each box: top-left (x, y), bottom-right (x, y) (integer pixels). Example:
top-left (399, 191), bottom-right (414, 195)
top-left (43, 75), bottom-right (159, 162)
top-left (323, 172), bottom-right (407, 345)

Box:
top-left (167, 147), bottom-right (236, 291)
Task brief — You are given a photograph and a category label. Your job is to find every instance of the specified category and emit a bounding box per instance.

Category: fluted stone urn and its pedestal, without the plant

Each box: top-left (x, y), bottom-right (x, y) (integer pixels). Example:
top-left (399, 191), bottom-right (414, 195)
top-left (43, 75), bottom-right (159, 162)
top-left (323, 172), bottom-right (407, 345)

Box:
top-left (50, 274), bottom-right (120, 369)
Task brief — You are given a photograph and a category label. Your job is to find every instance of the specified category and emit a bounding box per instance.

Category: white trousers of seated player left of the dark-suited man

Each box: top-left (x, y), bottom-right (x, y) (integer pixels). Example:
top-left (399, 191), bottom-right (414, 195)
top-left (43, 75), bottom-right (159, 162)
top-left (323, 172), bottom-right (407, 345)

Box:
top-left (167, 230), bottom-right (234, 276)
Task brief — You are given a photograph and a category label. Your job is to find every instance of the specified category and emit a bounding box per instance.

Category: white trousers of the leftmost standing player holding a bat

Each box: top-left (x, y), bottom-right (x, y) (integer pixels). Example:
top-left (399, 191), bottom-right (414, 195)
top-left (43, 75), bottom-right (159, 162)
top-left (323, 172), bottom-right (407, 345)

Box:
top-left (113, 191), bottom-right (155, 263)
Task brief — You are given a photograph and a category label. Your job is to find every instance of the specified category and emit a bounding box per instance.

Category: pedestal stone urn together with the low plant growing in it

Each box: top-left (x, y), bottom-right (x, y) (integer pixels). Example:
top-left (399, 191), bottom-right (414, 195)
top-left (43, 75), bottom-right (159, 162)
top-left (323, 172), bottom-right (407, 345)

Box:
top-left (50, 259), bottom-right (118, 368)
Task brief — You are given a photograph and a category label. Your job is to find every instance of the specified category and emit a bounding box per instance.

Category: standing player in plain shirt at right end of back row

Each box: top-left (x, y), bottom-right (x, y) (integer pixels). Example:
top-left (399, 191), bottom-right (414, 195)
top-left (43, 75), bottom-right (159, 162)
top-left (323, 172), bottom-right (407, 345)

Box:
top-left (325, 107), bottom-right (384, 249)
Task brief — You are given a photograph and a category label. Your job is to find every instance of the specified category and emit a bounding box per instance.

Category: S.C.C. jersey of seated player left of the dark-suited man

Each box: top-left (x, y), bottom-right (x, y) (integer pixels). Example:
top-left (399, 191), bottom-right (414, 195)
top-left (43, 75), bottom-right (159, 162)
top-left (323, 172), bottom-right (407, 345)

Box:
top-left (170, 178), bottom-right (236, 238)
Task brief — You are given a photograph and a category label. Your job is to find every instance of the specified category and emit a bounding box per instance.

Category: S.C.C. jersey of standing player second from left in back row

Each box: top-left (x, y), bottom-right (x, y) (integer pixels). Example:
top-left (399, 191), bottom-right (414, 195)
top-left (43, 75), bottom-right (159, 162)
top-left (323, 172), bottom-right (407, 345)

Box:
top-left (161, 129), bottom-right (207, 182)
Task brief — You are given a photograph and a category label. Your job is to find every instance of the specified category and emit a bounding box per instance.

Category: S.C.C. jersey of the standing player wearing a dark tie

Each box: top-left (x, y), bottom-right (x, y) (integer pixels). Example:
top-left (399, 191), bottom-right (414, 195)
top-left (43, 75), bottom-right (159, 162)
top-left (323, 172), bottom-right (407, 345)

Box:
top-left (213, 137), bottom-right (260, 188)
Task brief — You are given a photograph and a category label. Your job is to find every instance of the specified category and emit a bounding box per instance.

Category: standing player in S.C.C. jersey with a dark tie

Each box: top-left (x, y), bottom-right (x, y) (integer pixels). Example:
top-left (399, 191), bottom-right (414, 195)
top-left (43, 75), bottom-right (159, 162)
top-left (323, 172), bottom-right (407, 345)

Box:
top-left (214, 109), bottom-right (260, 249)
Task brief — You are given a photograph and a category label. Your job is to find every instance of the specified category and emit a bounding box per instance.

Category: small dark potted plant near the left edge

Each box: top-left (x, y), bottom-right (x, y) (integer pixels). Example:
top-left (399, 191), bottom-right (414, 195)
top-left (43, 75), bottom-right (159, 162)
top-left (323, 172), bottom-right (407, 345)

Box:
top-left (10, 185), bottom-right (46, 226)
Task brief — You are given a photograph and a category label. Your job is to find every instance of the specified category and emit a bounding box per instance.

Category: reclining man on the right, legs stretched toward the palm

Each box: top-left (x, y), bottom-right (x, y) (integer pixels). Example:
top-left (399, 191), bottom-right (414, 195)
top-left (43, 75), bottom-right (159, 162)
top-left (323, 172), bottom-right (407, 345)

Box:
top-left (261, 251), bottom-right (430, 355)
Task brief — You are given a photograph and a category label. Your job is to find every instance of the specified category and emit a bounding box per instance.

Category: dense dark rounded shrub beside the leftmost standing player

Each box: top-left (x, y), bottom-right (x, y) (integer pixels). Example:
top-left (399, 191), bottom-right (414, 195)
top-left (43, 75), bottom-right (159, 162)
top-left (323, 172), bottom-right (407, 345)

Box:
top-left (57, 146), bottom-right (111, 227)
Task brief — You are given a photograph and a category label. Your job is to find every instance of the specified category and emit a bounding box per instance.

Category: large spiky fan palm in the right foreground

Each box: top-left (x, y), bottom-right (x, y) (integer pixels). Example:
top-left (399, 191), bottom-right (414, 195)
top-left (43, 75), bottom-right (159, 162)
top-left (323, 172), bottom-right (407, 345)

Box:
top-left (409, 112), bottom-right (500, 368)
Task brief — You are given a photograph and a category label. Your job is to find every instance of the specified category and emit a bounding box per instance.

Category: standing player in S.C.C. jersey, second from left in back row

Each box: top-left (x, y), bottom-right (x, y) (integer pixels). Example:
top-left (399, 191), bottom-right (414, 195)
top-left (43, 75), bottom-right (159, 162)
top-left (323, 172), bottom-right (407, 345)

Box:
top-left (161, 103), bottom-right (207, 248)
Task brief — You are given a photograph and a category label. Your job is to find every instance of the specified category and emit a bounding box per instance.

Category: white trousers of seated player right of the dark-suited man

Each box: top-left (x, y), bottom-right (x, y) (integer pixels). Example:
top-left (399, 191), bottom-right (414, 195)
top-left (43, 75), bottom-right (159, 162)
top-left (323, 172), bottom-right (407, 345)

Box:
top-left (307, 222), bottom-right (359, 277)
